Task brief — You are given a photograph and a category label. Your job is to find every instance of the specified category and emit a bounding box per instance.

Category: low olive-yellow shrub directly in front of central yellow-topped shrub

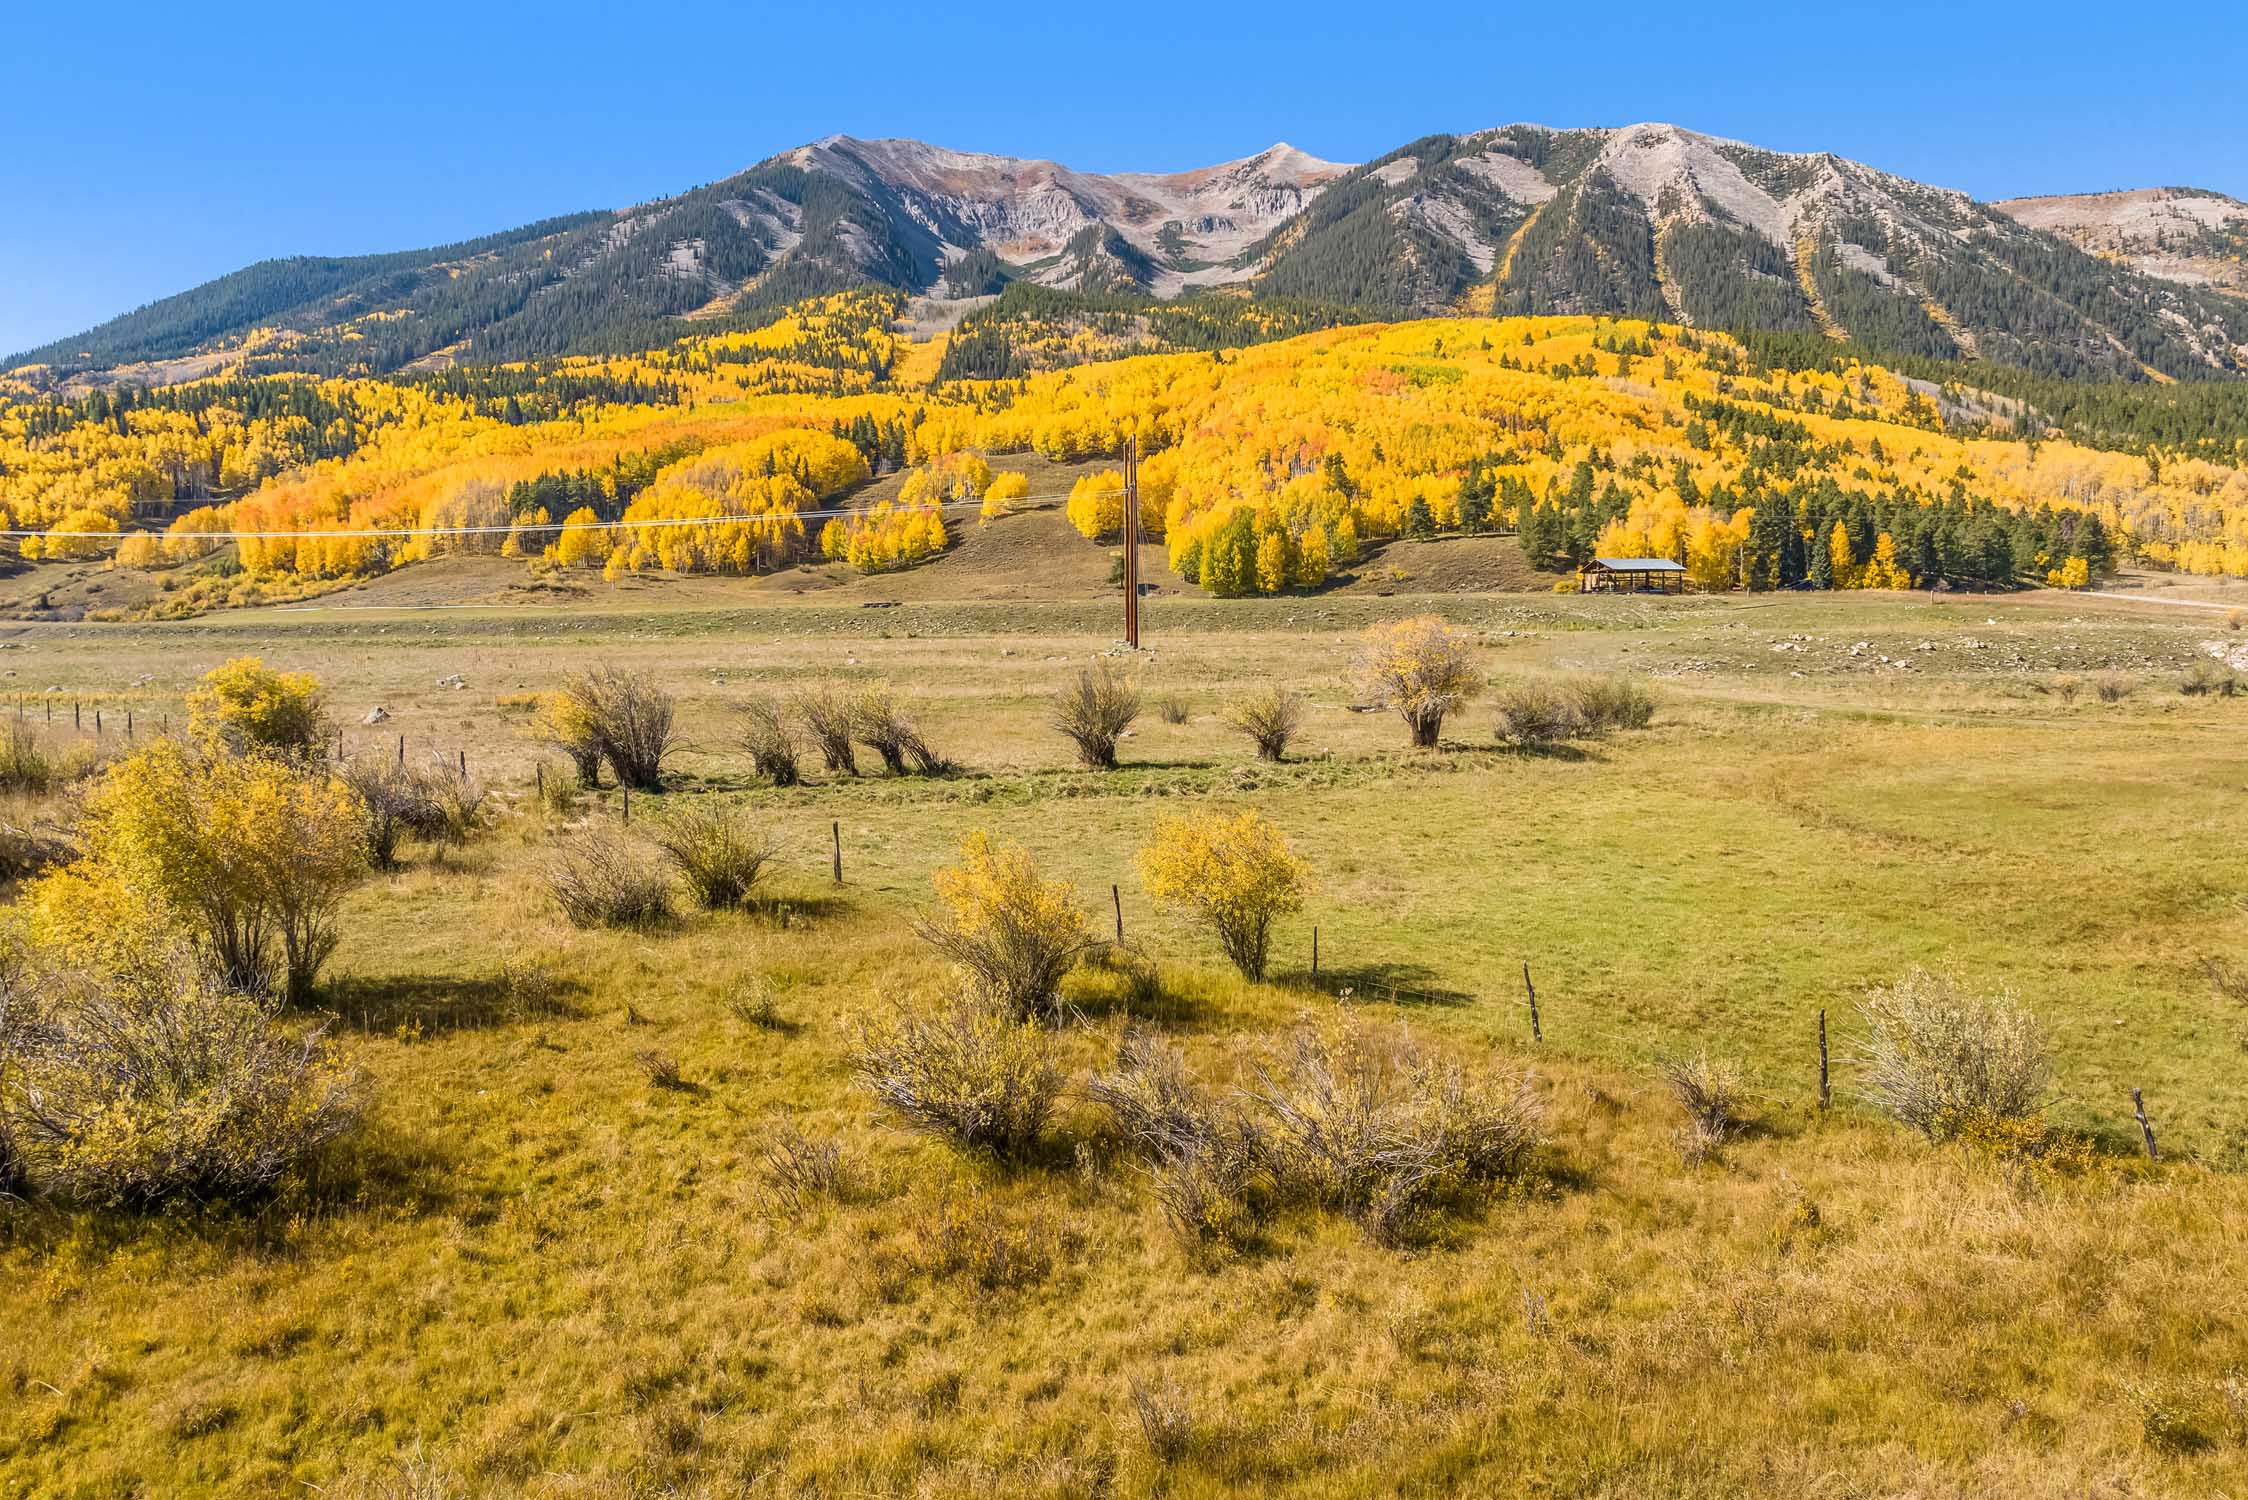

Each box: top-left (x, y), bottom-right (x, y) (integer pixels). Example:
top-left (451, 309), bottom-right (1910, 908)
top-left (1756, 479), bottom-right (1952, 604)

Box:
top-left (852, 999), bottom-right (1061, 1158)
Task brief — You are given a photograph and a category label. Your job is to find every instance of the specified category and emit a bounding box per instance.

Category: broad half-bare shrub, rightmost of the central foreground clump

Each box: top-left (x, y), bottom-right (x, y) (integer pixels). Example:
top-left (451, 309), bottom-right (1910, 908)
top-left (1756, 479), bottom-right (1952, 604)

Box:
top-left (1252, 1025), bottom-right (1542, 1246)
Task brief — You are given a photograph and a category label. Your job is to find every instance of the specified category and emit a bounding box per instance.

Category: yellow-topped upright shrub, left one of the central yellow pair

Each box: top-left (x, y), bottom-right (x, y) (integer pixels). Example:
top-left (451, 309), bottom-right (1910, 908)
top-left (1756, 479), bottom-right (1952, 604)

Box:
top-left (915, 832), bottom-right (1093, 1021)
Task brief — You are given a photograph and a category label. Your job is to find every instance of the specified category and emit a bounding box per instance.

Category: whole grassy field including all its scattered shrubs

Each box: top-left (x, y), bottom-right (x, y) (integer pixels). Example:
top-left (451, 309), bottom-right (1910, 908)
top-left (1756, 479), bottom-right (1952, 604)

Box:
top-left (0, 594), bottom-right (2248, 1498)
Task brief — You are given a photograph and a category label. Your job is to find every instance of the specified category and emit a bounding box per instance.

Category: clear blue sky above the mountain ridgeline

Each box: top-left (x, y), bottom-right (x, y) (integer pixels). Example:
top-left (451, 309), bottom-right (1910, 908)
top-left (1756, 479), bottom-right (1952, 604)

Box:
top-left (0, 0), bottom-right (2248, 355)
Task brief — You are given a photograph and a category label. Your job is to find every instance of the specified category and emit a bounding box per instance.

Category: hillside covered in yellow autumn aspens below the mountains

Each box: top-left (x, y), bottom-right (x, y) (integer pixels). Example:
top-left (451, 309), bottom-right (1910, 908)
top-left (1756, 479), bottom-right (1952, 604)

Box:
top-left (0, 290), bottom-right (2248, 607)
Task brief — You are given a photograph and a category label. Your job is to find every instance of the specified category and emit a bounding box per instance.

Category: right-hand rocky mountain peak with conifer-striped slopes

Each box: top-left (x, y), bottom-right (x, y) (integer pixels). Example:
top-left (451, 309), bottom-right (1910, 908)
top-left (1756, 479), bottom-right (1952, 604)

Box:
top-left (1261, 126), bottom-right (2248, 376)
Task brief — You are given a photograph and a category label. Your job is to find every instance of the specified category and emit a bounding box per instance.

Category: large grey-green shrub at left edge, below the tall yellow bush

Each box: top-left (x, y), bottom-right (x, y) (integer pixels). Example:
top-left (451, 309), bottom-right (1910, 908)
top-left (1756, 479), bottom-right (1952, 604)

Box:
top-left (0, 949), bottom-right (360, 1205)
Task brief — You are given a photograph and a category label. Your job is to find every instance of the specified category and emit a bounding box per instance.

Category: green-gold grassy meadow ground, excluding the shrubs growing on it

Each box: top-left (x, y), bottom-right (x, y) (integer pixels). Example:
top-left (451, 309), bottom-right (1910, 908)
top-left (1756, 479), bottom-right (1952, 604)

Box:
top-left (0, 568), bottom-right (2248, 1498)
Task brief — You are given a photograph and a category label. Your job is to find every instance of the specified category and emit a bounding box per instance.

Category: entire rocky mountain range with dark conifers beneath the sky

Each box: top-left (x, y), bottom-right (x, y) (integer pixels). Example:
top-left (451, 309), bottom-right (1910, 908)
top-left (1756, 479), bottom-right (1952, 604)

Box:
top-left (7, 124), bottom-right (2248, 380)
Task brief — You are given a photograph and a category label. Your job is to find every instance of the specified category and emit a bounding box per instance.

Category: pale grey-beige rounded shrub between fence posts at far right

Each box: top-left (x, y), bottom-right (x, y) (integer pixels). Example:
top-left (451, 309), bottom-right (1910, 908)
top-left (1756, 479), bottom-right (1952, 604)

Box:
top-left (1861, 969), bottom-right (2052, 1138)
